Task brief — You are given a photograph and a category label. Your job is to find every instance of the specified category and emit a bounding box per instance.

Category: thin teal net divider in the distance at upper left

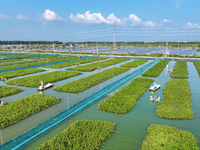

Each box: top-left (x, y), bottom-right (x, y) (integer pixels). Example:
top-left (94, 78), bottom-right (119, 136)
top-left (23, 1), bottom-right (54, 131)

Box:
top-left (0, 56), bottom-right (97, 73)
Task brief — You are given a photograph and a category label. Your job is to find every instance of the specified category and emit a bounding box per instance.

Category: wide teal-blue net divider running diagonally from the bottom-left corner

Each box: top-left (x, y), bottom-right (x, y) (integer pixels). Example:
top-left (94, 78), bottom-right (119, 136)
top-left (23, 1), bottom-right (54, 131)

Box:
top-left (0, 59), bottom-right (160, 150)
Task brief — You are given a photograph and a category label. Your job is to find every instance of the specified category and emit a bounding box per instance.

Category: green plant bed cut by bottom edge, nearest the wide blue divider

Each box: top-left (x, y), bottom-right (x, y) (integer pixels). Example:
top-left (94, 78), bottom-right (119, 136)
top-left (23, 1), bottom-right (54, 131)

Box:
top-left (36, 120), bottom-right (115, 150)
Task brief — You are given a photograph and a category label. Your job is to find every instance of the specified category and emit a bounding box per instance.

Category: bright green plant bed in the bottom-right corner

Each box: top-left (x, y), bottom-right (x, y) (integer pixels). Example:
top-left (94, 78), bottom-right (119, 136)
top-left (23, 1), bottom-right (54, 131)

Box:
top-left (141, 124), bottom-right (199, 150)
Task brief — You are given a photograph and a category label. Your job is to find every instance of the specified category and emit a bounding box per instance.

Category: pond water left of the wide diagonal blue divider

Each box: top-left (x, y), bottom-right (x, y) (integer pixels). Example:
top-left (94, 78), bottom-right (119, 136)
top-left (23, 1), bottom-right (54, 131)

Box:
top-left (1, 60), bottom-right (152, 142)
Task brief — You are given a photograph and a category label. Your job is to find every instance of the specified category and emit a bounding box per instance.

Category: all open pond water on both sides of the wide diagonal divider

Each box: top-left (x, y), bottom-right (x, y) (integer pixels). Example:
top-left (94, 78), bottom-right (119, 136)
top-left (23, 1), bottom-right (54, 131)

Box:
top-left (1, 55), bottom-right (200, 150)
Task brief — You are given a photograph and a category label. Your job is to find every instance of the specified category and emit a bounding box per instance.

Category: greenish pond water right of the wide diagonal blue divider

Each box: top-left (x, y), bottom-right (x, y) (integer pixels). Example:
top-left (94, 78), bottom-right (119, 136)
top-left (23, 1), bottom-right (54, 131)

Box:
top-left (27, 61), bottom-right (200, 150)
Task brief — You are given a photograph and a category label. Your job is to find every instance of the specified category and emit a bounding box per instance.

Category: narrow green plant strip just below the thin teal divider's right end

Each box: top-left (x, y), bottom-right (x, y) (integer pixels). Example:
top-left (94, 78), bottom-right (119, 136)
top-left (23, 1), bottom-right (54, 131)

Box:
top-left (45, 57), bottom-right (107, 68)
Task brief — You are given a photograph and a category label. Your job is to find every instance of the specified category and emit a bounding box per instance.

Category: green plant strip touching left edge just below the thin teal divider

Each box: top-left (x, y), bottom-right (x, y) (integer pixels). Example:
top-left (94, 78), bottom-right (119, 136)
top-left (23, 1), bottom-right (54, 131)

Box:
top-left (0, 68), bottom-right (45, 79)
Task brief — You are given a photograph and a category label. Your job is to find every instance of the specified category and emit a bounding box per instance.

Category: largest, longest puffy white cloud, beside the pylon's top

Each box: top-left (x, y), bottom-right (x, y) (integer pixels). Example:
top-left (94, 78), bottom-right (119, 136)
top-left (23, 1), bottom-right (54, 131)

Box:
top-left (69, 11), bottom-right (121, 24)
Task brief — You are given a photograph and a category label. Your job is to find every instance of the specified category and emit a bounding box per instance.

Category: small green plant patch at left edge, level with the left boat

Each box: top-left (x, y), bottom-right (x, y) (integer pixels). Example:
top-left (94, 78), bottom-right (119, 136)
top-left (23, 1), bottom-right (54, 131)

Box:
top-left (0, 85), bottom-right (23, 98)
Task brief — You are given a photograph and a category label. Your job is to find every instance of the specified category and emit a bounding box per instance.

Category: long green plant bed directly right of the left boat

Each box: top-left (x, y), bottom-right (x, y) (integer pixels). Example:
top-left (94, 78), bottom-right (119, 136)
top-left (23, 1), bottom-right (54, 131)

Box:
top-left (54, 67), bottom-right (129, 93)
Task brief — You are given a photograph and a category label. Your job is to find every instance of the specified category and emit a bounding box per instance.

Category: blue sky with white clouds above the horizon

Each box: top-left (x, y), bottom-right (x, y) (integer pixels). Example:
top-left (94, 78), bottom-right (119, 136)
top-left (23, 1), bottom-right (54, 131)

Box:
top-left (0, 0), bottom-right (200, 42)
